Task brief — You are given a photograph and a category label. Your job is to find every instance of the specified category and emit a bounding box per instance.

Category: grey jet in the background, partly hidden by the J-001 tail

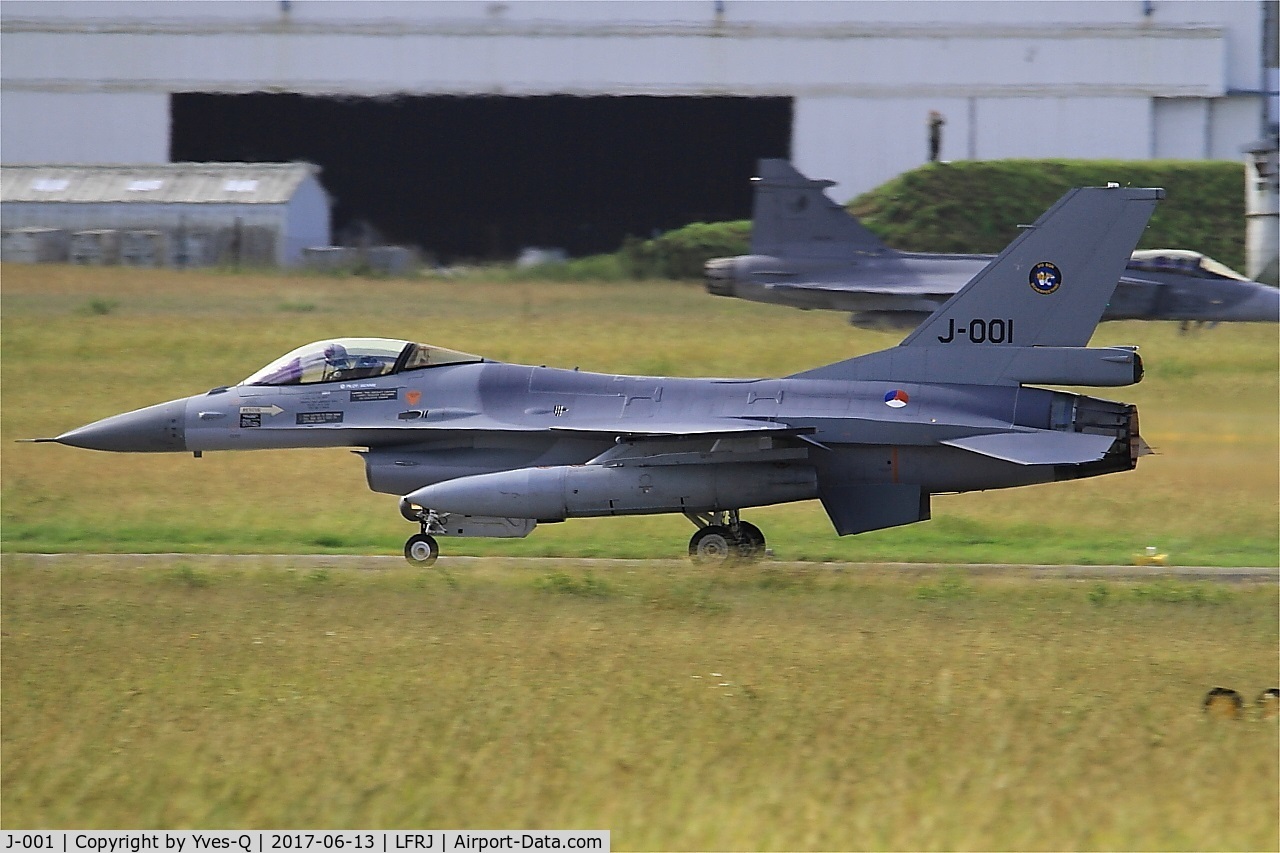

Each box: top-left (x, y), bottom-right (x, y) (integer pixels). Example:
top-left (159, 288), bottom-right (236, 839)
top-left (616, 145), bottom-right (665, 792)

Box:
top-left (704, 160), bottom-right (1280, 329)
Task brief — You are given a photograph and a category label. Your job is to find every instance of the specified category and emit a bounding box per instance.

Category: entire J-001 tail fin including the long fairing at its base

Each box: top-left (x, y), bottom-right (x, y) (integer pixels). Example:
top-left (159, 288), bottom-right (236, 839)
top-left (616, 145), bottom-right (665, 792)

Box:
top-left (795, 186), bottom-right (1165, 386)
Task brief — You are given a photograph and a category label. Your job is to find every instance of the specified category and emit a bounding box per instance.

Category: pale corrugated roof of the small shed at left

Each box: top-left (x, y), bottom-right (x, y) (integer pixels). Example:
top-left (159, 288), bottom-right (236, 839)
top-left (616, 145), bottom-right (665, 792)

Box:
top-left (0, 163), bottom-right (320, 204)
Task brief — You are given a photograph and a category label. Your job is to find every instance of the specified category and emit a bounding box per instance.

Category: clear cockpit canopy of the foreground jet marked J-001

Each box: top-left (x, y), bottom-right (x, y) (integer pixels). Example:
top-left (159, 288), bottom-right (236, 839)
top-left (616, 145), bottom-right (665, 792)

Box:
top-left (239, 338), bottom-right (484, 386)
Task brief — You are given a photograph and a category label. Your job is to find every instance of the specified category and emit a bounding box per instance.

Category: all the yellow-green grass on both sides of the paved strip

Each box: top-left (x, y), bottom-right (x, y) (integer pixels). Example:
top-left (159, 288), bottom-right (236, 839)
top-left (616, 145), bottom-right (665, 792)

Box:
top-left (0, 265), bottom-right (1280, 849)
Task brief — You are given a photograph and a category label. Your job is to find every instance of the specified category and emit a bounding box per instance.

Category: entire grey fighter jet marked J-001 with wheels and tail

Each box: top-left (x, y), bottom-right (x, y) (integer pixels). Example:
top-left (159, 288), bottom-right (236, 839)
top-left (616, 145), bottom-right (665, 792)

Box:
top-left (36, 187), bottom-right (1164, 565)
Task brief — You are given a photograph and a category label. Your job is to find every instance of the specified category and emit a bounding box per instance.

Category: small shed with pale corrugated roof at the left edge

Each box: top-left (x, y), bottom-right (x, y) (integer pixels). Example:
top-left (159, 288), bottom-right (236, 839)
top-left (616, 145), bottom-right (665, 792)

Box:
top-left (0, 163), bottom-right (330, 266)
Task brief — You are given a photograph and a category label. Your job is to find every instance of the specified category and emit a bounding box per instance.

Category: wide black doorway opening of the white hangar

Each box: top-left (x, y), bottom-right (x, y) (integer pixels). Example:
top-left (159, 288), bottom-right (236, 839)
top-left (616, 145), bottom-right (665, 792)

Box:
top-left (169, 93), bottom-right (792, 263)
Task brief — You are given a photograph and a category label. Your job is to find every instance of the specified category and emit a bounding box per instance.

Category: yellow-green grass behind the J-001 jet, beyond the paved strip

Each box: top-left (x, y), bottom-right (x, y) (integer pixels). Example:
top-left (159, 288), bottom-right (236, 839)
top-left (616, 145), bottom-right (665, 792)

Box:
top-left (0, 265), bottom-right (1280, 566)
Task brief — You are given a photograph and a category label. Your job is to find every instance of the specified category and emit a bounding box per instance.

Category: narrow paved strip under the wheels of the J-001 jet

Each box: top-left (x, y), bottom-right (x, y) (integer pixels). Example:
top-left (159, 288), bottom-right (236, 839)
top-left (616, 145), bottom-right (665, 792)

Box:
top-left (10, 553), bottom-right (1280, 584)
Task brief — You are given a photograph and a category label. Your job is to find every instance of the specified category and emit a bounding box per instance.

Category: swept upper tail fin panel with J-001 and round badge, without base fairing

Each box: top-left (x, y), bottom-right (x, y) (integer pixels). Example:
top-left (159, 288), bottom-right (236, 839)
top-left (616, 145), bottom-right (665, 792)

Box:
top-left (900, 186), bottom-right (1165, 347)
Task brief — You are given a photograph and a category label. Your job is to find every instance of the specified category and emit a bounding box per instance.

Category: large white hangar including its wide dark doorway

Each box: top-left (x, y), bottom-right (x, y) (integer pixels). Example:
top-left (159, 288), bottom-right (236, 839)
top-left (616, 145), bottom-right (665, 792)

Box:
top-left (0, 0), bottom-right (1275, 256)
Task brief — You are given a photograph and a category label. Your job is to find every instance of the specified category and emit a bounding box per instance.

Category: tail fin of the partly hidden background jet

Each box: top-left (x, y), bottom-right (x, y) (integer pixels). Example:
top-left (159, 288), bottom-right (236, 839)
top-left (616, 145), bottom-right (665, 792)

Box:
top-left (751, 160), bottom-right (893, 257)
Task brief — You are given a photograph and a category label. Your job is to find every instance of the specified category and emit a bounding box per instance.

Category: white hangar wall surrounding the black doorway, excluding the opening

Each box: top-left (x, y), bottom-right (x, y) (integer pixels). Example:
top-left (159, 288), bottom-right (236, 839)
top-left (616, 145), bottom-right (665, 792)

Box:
top-left (0, 0), bottom-right (1262, 197)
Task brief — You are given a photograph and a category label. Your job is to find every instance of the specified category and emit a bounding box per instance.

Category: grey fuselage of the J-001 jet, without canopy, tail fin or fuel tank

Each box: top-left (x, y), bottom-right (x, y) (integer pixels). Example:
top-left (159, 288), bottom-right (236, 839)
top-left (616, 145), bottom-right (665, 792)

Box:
top-left (59, 362), bottom-right (1130, 515)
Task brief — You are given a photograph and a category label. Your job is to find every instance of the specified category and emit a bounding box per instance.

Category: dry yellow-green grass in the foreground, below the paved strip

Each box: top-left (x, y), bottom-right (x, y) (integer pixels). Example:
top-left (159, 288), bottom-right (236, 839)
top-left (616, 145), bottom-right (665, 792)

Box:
top-left (0, 555), bottom-right (1280, 850)
